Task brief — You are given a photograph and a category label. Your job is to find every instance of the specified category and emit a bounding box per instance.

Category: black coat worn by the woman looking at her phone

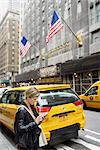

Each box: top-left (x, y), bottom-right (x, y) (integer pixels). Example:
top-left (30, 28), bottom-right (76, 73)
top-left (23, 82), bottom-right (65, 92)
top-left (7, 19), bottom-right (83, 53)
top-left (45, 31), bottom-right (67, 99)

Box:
top-left (14, 103), bottom-right (41, 150)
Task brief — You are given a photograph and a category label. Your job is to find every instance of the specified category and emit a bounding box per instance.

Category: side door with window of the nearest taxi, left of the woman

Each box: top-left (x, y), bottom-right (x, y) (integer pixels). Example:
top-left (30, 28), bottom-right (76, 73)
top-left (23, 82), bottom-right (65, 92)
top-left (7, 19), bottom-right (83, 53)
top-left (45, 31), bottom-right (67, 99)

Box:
top-left (0, 91), bottom-right (18, 131)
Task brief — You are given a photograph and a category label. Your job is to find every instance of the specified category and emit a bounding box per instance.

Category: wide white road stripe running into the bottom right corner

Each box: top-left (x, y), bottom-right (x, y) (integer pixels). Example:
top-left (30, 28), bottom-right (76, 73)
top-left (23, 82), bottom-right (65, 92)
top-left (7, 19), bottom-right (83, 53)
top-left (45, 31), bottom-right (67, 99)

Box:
top-left (71, 139), bottom-right (100, 150)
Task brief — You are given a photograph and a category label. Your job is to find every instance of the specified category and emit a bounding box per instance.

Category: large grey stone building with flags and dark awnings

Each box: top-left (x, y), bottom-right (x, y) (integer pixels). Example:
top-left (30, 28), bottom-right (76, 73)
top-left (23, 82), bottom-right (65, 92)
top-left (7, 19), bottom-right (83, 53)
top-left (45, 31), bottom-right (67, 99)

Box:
top-left (16, 0), bottom-right (100, 93)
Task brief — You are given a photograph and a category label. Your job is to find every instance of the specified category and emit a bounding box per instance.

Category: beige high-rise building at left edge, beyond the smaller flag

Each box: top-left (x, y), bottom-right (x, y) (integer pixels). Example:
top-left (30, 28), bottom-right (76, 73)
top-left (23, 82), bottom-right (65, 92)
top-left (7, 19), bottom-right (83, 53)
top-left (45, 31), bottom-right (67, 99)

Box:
top-left (0, 11), bottom-right (19, 85)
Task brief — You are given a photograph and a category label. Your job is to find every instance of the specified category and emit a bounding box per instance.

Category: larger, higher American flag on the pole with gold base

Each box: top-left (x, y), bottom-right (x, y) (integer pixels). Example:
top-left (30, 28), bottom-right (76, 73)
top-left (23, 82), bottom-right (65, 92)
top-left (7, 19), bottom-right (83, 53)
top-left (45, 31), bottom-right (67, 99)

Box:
top-left (46, 11), bottom-right (63, 43)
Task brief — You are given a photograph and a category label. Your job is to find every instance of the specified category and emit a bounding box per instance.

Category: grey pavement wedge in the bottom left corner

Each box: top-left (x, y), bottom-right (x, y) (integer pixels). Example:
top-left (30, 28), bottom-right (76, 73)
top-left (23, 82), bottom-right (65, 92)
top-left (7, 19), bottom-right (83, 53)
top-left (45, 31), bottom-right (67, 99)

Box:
top-left (0, 131), bottom-right (16, 150)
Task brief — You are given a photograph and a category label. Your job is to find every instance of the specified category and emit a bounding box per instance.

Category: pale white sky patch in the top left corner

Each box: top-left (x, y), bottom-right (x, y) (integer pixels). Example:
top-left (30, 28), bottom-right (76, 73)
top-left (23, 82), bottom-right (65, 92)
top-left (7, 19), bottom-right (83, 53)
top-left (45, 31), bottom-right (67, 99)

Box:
top-left (0, 0), bottom-right (8, 21)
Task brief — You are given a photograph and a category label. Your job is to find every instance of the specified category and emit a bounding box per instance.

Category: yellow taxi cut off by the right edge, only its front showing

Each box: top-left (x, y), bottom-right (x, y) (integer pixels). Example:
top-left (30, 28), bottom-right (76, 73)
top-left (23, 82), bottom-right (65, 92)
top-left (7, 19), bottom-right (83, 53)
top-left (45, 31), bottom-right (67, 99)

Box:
top-left (79, 81), bottom-right (100, 109)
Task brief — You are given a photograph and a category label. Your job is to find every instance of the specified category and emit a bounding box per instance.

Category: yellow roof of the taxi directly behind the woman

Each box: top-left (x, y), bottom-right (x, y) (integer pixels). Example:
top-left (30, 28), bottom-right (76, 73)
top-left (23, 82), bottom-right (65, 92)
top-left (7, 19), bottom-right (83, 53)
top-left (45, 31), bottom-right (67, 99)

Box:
top-left (7, 84), bottom-right (70, 91)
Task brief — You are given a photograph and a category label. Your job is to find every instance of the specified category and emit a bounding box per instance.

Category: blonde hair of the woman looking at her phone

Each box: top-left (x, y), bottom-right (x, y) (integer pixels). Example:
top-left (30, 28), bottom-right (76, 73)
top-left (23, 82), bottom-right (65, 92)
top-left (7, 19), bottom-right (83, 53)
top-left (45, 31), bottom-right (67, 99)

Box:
top-left (25, 87), bottom-right (40, 98)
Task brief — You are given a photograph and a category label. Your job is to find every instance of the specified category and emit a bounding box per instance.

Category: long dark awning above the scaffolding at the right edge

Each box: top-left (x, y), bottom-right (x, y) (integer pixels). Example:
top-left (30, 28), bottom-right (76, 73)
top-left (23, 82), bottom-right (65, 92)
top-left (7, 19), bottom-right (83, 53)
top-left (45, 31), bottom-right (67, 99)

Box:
top-left (61, 54), bottom-right (100, 75)
